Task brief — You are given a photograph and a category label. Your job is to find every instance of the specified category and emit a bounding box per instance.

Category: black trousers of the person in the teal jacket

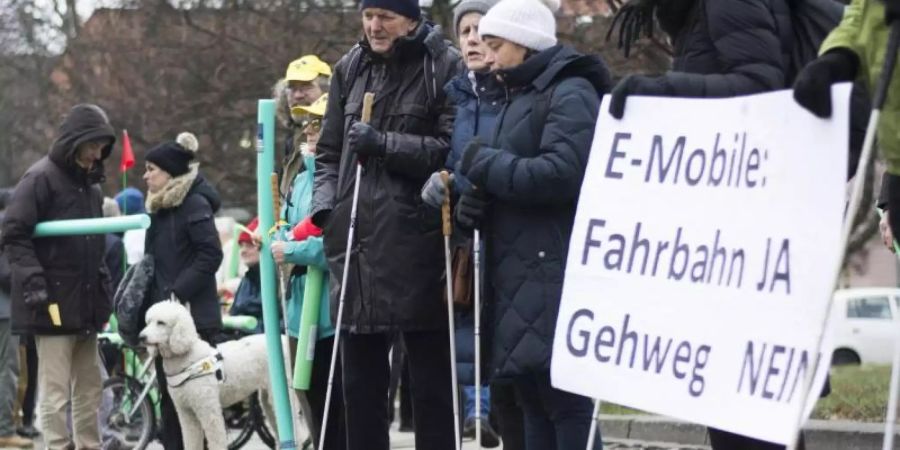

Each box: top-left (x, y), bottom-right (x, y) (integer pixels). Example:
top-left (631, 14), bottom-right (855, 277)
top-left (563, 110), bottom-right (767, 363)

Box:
top-left (290, 337), bottom-right (347, 450)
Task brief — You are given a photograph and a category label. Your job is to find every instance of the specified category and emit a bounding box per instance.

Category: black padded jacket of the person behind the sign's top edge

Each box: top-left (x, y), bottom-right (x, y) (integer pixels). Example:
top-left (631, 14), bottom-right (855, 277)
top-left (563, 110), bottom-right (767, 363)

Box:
top-left (656, 0), bottom-right (793, 98)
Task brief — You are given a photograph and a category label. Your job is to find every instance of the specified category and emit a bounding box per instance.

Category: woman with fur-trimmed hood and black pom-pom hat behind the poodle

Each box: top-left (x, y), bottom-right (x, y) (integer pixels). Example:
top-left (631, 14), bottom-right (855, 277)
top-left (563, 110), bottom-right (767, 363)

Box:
top-left (144, 133), bottom-right (222, 450)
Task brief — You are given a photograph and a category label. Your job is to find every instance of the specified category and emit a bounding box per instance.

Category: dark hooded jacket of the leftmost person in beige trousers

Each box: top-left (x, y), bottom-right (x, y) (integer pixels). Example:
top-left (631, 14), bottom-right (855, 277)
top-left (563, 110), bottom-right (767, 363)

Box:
top-left (0, 104), bottom-right (116, 335)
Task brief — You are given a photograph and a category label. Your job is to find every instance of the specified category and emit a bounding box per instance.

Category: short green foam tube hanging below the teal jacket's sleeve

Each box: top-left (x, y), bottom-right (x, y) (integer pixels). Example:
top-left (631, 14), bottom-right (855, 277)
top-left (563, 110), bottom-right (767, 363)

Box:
top-left (293, 266), bottom-right (325, 391)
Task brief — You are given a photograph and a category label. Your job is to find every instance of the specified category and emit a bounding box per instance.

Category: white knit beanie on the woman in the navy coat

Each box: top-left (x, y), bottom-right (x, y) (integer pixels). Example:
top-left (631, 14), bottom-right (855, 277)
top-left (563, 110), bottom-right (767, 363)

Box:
top-left (478, 0), bottom-right (560, 51)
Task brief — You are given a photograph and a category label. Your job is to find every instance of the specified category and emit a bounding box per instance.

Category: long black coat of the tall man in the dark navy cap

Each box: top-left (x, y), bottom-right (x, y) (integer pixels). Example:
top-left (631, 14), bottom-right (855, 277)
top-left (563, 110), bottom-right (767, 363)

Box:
top-left (311, 24), bottom-right (460, 333)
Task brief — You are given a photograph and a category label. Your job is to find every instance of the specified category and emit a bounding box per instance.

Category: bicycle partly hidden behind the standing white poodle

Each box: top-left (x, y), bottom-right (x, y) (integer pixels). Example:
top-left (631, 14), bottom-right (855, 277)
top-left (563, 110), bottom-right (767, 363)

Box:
top-left (98, 316), bottom-right (275, 450)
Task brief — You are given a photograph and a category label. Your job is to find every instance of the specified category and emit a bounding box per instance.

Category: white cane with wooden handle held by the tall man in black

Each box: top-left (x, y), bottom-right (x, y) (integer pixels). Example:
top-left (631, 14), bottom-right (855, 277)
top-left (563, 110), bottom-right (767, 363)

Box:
top-left (319, 92), bottom-right (375, 450)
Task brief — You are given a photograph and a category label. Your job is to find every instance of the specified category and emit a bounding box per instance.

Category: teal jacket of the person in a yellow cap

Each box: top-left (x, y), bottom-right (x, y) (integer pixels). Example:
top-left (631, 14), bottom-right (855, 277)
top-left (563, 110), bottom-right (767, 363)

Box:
top-left (277, 155), bottom-right (334, 339)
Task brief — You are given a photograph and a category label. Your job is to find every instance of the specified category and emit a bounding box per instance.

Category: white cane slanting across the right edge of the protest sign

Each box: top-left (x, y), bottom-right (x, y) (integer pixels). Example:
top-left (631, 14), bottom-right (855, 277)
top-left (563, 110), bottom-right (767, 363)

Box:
top-left (787, 21), bottom-right (900, 450)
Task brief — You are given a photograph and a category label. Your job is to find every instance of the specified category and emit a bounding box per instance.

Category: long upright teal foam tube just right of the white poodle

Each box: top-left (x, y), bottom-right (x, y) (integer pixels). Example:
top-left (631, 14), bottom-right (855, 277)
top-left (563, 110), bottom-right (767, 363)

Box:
top-left (256, 100), bottom-right (297, 450)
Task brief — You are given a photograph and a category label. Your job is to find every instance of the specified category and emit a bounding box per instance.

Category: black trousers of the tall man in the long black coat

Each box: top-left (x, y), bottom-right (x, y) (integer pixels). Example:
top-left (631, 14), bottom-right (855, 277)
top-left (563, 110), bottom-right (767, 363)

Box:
top-left (341, 331), bottom-right (456, 450)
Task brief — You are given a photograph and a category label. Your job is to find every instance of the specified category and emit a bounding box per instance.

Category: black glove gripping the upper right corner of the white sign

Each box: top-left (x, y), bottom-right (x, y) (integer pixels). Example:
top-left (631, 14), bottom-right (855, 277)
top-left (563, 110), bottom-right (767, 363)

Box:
top-left (794, 48), bottom-right (859, 119)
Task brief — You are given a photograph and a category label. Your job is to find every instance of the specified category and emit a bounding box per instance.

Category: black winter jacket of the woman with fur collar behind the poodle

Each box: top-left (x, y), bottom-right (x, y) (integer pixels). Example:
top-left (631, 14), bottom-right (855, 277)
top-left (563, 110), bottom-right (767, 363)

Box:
top-left (145, 171), bottom-right (223, 330)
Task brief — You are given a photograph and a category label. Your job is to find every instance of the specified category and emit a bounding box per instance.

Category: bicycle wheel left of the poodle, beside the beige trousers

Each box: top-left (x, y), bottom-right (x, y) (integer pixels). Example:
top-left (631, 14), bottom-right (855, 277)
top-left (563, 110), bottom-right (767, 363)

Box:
top-left (101, 377), bottom-right (156, 450)
